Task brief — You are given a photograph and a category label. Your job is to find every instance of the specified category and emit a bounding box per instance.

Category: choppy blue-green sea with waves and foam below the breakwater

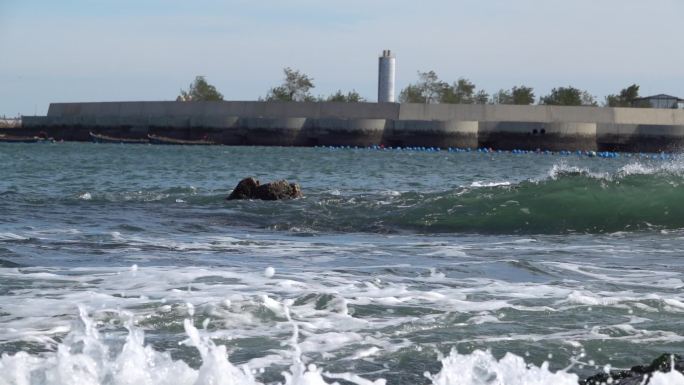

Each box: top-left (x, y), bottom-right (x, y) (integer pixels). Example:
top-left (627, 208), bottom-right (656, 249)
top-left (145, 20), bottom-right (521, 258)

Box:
top-left (0, 143), bottom-right (684, 385)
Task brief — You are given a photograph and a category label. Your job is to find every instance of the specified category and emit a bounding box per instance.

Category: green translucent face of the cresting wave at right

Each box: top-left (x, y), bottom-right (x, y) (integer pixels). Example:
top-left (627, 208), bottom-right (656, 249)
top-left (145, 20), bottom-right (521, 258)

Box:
top-left (392, 170), bottom-right (684, 233)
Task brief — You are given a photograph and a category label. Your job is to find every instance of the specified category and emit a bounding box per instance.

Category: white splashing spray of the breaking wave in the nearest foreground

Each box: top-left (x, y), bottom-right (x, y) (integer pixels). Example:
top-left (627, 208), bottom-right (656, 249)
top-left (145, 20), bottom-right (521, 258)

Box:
top-left (0, 303), bottom-right (584, 385)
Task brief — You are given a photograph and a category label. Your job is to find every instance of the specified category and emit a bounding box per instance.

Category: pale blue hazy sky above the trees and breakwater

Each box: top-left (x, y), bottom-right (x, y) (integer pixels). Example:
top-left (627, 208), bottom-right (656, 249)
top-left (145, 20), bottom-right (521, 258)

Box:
top-left (0, 0), bottom-right (684, 116)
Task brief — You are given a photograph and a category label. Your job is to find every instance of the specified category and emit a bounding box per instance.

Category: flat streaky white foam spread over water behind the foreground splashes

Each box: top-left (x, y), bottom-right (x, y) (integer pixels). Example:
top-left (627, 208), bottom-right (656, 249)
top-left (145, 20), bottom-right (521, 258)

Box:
top-left (0, 232), bottom-right (684, 383)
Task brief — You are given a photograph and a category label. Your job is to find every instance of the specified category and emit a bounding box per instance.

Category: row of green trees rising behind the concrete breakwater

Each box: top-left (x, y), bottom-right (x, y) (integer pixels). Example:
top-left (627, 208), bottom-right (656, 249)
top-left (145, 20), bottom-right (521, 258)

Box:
top-left (176, 67), bottom-right (651, 107)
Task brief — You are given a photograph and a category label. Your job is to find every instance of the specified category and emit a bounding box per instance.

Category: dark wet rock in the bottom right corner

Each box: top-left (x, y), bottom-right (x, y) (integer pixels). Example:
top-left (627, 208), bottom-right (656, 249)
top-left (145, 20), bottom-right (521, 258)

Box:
top-left (579, 354), bottom-right (684, 385)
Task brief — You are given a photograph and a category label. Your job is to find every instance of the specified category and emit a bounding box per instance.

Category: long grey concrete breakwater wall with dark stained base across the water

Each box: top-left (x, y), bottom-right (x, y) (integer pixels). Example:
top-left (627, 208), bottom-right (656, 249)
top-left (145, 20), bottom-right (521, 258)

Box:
top-left (16, 102), bottom-right (684, 152)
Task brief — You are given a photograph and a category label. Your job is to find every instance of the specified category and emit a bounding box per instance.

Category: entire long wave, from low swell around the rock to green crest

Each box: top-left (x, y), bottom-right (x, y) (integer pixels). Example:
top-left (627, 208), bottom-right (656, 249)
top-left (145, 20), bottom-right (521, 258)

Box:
top-left (8, 161), bottom-right (684, 234)
